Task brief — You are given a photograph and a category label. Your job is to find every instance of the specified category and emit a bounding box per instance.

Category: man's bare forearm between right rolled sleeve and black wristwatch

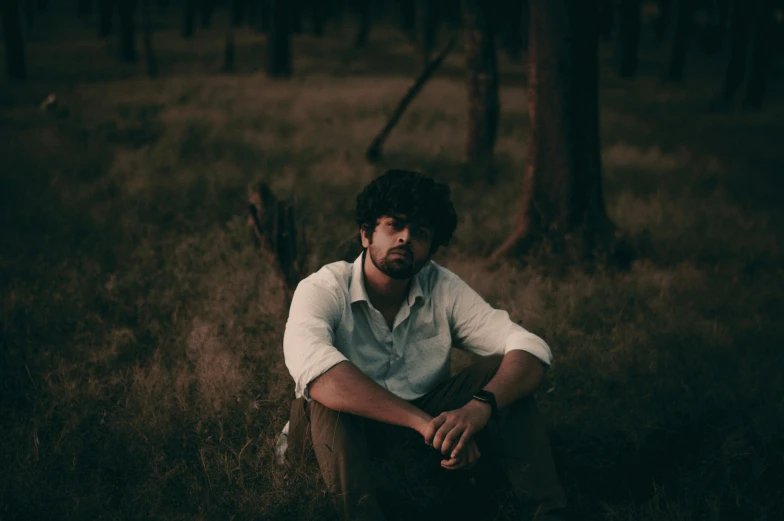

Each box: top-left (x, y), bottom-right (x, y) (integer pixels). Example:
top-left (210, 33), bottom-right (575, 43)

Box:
top-left (484, 350), bottom-right (544, 409)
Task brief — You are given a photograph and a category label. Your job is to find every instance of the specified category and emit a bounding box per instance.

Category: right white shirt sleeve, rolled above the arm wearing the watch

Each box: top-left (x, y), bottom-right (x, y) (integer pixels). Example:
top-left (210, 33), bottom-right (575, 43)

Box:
top-left (449, 275), bottom-right (553, 367)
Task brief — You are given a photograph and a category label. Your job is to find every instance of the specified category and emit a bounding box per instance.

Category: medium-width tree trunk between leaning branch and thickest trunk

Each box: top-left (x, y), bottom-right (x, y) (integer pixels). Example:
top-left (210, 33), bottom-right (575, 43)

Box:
top-left (462, 0), bottom-right (500, 165)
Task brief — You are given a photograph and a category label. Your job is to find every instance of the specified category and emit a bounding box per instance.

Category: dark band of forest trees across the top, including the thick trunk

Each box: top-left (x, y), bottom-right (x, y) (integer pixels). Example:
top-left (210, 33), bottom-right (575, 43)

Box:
top-left (0, 0), bottom-right (784, 260)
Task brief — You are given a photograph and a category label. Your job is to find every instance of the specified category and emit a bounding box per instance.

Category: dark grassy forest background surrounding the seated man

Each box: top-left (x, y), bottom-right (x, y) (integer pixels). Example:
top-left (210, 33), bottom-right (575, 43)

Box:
top-left (0, 0), bottom-right (784, 520)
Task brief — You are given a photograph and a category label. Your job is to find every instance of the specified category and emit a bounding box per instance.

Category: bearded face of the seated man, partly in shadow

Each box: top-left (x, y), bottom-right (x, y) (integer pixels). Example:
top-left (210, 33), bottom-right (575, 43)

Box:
top-left (362, 215), bottom-right (433, 280)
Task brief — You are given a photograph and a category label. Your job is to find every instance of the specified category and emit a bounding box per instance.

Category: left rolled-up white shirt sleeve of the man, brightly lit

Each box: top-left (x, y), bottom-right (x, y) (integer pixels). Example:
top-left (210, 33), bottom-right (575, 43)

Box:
top-left (283, 279), bottom-right (348, 401)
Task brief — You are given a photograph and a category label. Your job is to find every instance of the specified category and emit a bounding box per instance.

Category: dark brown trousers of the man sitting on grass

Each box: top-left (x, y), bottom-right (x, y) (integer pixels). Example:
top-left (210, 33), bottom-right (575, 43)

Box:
top-left (288, 356), bottom-right (566, 520)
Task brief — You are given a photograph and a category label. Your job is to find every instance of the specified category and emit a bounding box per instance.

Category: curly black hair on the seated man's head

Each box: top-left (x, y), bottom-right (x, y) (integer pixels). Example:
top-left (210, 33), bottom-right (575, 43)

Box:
top-left (356, 170), bottom-right (457, 253)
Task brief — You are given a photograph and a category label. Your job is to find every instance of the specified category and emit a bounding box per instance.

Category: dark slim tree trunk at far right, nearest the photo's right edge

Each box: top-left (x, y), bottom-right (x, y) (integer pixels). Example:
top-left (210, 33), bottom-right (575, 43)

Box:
top-left (743, 0), bottom-right (776, 109)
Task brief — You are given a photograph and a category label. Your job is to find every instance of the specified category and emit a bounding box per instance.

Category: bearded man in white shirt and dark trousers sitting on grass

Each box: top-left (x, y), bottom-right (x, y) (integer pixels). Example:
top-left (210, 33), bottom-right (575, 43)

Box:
top-left (283, 170), bottom-right (566, 519)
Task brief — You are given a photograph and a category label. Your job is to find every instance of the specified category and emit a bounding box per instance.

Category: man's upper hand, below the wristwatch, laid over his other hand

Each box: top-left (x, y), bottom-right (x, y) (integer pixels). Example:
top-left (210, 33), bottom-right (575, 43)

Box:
top-left (425, 400), bottom-right (492, 461)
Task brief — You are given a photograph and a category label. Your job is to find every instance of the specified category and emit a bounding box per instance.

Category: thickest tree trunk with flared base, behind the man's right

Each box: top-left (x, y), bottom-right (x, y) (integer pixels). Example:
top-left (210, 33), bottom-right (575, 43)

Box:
top-left (491, 0), bottom-right (611, 262)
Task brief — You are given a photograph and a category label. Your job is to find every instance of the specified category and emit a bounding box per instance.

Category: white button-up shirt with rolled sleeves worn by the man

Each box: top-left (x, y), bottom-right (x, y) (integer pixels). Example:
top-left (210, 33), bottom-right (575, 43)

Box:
top-left (283, 254), bottom-right (552, 400)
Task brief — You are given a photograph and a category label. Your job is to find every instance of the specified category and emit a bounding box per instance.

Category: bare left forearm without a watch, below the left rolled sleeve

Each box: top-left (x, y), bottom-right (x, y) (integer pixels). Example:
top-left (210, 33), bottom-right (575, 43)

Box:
top-left (308, 362), bottom-right (431, 433)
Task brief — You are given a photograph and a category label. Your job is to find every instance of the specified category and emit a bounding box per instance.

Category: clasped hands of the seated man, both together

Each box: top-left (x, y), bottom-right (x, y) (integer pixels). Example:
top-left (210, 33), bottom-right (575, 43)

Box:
top-left (422, 400), bottom-right (492, 470)
